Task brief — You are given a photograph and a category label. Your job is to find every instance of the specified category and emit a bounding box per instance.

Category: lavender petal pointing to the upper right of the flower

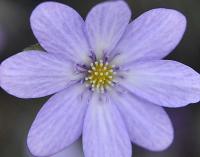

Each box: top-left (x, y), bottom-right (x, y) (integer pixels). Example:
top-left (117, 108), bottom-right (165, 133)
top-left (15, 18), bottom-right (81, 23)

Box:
top-left (113, 8), bottom-right (186, 65)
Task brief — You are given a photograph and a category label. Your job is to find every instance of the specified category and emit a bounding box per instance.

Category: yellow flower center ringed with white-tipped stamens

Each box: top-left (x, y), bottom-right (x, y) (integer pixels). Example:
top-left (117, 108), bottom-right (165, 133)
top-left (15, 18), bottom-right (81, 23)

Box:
top-left (85, 60), bottom-right (115, 93)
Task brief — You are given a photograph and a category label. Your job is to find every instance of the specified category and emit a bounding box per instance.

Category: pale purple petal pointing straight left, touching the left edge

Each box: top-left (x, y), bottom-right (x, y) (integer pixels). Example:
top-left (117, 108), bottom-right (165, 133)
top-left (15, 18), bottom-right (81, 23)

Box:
top-left (0, 51), bottom-right (79, 98)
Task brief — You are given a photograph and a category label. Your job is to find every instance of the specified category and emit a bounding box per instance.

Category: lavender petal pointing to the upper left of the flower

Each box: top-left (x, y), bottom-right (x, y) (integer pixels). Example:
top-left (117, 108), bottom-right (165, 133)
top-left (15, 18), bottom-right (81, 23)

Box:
top-left (30, 2), bottom-right (89, 62)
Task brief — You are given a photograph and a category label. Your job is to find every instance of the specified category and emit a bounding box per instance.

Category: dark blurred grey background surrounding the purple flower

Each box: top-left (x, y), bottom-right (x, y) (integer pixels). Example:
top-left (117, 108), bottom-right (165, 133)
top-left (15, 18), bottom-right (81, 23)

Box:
top-left (0, 0), bottom-right (200, 157)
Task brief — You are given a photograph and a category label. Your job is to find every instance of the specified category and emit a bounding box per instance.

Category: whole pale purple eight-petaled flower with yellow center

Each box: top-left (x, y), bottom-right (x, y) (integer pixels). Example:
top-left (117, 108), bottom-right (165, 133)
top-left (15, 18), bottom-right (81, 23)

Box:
top-left (1, 1), bottom-right (200, 157)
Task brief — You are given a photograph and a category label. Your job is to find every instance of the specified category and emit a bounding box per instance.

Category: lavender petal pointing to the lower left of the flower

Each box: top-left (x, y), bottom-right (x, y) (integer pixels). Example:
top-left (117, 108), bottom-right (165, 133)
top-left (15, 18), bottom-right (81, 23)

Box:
top-left (27, 85), bottom-right (89, 156)
